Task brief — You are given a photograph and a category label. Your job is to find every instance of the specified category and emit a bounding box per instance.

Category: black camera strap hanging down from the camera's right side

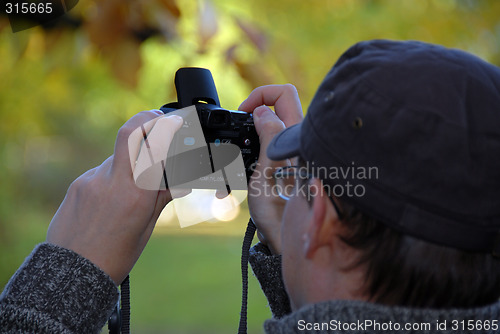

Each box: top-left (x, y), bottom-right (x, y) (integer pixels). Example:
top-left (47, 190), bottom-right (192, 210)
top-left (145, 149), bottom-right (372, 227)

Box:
top-left (238, 218), bottom-right (257, 334)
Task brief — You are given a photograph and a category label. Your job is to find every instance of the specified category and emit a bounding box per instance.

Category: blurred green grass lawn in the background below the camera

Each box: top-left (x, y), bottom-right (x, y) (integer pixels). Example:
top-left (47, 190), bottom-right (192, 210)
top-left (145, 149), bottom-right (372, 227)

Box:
top-left (0, 210), bottom-right (271, 334)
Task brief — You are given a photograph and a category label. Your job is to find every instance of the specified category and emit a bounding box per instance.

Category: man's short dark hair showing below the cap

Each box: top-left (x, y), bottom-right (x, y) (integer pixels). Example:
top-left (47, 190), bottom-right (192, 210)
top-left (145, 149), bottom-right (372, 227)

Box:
top-left (341, 202), bottom-right (500, 308)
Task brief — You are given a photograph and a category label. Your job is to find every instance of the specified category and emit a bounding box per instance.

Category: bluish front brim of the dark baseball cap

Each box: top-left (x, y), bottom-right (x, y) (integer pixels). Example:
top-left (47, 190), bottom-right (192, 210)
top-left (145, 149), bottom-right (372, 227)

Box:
top-left (267, 123), bottom-right (302, 160)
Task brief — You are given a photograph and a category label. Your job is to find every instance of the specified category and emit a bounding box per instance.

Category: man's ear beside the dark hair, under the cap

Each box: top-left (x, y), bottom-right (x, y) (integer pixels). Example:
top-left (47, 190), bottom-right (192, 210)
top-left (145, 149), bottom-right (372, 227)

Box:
top-left (304, 178), bottom-right (340, 259)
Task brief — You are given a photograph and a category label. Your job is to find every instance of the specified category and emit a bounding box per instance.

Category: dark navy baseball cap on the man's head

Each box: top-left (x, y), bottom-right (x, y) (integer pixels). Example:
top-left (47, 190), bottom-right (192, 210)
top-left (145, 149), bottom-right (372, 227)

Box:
top-left (267, 40), bottom-right (500, 255)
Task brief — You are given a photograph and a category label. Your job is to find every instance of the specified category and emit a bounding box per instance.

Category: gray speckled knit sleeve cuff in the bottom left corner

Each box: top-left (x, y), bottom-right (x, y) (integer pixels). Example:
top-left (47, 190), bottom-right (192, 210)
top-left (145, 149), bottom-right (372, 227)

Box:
top-left (0, 243), bottom-right (119, 334)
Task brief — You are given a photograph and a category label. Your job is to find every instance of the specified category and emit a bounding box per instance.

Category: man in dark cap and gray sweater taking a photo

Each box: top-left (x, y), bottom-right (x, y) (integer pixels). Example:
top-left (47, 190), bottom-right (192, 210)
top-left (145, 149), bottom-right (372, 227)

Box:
top-left (0, 41), bottom-right (500, 333)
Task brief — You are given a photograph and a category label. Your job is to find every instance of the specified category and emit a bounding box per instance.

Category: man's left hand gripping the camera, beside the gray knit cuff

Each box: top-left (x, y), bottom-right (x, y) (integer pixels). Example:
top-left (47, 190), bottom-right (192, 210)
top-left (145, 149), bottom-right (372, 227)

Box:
top-left (47, 111), bottom-right (182, 285)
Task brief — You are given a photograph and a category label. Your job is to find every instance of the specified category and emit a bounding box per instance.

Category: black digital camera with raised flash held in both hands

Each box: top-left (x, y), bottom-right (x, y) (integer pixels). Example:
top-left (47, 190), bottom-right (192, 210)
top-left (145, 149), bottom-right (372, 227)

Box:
top-left (160, 67), bottom-right (260, 191)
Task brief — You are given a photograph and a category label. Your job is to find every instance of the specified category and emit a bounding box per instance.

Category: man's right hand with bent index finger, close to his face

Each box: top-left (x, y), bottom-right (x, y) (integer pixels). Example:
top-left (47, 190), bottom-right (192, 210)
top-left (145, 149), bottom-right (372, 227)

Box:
top-left (239, 84), bottom-right (304, 254)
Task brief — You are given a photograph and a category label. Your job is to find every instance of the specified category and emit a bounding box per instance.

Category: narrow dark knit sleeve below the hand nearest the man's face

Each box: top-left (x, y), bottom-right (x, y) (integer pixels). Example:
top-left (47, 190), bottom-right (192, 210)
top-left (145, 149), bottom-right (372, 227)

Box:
top-left (249, 243), bottom-right (291, 319)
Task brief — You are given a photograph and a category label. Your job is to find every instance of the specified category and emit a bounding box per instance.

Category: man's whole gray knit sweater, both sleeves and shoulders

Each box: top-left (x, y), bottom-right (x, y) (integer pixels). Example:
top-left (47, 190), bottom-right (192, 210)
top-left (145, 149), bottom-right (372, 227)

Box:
top-left (0, 244), bottom-right (500, 334)
